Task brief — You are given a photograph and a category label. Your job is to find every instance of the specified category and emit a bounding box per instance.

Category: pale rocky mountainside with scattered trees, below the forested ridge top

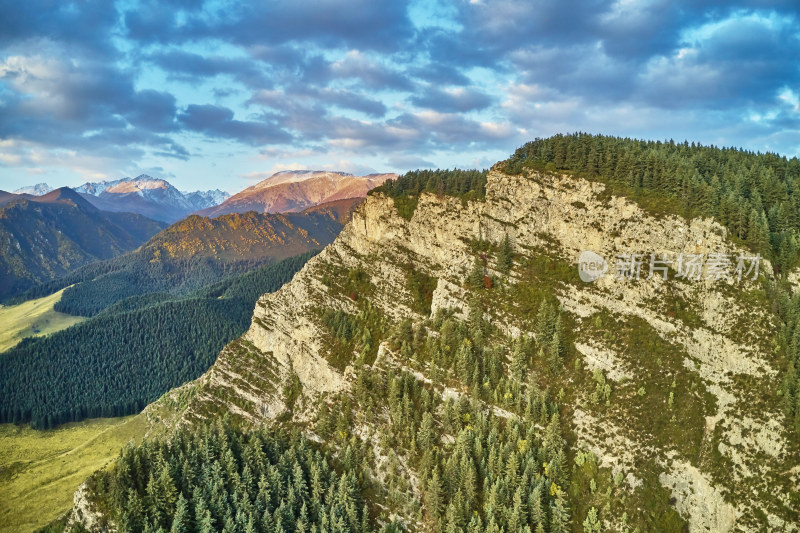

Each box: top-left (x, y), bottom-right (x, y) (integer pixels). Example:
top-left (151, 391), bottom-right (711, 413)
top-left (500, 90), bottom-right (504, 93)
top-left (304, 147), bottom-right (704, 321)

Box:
top-left (138, 166), bottom-right (800, 531)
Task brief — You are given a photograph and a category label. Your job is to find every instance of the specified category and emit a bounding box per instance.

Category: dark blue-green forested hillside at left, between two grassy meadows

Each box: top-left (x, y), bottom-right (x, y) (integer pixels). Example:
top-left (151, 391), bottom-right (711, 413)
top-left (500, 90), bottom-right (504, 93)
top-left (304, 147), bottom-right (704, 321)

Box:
top-left (0, 252), bottom-right (314, 428)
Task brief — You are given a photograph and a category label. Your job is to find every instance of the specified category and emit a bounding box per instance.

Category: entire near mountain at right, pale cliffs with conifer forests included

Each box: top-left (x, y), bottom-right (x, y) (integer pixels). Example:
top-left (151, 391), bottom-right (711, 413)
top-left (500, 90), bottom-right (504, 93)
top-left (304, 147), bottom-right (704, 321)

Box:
top-left (47, 135), bottom-right (800, 533)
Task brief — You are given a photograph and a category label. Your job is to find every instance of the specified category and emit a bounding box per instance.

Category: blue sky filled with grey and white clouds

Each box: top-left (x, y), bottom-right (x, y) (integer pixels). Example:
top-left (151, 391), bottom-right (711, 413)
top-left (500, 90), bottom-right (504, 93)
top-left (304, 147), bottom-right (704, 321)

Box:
top-left (0, 0), bottom-right (800, 192)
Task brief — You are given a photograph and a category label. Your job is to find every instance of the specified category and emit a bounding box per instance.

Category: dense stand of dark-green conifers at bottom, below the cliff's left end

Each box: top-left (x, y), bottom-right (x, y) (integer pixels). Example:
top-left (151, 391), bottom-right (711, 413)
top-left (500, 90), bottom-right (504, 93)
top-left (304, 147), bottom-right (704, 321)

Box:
top-left (82, 421), bottom-right (373, 533)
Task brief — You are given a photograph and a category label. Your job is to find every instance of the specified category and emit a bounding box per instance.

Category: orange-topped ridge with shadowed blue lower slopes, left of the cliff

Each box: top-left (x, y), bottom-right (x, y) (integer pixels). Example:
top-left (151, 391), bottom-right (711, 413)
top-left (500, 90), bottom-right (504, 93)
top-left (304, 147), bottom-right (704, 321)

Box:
top-left (45, 199), bottom-right (361, 316)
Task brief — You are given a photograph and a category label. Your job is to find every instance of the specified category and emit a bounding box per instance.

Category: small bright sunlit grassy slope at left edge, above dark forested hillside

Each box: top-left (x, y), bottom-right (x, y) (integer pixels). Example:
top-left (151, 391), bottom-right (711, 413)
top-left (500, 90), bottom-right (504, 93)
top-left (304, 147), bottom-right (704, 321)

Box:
top-left (0, 289), bottom-right (85, 352)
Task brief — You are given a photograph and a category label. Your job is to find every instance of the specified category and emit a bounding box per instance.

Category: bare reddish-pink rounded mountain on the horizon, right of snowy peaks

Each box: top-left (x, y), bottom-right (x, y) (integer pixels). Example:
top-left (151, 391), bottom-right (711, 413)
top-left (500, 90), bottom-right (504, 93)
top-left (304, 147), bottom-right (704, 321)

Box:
top-left (197, 170), bottom-right (397, 217)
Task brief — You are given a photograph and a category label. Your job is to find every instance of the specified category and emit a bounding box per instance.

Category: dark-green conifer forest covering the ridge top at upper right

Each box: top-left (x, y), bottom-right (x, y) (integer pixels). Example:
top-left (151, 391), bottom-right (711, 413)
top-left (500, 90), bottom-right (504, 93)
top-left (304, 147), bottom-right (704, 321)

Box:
top-left (503, 133), bottom-right (800, 272)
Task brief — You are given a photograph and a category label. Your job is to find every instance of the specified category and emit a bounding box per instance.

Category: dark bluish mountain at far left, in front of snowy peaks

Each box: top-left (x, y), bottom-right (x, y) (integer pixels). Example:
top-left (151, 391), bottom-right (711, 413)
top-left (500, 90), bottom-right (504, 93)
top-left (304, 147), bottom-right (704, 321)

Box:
top-left (0, 187), bottom-right (165, 298)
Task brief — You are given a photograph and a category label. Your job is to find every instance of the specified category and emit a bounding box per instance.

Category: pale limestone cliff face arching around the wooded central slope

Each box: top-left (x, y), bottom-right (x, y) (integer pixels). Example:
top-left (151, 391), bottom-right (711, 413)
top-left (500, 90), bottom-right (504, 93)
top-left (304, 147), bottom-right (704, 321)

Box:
top-left (134, 167), bottom-right (800, 531)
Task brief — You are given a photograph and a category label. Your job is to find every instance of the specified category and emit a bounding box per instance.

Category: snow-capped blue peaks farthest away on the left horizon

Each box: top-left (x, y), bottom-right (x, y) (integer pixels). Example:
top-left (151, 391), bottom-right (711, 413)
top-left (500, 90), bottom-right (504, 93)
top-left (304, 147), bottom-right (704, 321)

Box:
top-left (14, 174), bottom-right (230, 222)
